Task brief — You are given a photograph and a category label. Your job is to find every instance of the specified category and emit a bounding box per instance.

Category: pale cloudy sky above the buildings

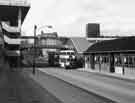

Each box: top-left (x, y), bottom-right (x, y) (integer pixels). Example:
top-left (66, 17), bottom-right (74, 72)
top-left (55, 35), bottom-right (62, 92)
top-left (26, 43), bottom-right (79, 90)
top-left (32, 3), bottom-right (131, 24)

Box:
top-left (22, 0), bottom-right (135, 37)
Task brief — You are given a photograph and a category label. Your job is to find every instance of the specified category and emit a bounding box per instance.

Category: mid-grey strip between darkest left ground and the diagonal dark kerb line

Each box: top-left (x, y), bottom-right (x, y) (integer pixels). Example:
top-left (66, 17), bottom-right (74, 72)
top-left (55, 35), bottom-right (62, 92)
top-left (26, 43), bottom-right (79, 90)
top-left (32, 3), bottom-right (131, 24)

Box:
top-left (23, 68), bottom-right (115, 103)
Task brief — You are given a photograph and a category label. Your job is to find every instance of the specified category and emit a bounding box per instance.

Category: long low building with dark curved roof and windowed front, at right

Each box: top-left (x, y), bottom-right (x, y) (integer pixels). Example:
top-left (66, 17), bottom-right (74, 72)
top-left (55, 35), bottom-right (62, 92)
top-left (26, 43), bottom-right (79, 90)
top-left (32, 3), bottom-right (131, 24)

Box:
top-left (85, 37), bottom-right (135, 76)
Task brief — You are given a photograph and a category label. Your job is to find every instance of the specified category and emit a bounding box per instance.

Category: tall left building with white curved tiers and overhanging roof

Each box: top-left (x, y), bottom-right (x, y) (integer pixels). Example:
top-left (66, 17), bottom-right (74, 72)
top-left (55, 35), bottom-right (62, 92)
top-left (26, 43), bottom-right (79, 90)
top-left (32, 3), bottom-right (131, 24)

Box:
top-left (0, 0), bottom-right (30, 66)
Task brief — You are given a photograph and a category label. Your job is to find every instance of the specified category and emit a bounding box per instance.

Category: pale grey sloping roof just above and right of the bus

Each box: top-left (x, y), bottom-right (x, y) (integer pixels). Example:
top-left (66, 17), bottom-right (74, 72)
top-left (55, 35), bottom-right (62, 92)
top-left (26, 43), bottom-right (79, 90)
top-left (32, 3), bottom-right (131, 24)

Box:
top-left (70, 37), bottom-right (93, 53)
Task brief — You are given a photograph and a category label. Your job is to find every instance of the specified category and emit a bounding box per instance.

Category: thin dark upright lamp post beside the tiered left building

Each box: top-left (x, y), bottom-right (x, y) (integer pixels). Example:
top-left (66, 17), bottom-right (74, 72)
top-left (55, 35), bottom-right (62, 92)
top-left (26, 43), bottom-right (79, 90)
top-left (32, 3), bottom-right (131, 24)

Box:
top-left (32, 25), bottom-right (37, 74)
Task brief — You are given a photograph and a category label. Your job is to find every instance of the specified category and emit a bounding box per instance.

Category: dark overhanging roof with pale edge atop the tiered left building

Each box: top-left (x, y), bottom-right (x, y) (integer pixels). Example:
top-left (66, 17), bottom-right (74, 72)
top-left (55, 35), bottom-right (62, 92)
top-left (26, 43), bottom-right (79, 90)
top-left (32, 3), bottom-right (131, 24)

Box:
top-left (0, 0), bottom-right (30, 22)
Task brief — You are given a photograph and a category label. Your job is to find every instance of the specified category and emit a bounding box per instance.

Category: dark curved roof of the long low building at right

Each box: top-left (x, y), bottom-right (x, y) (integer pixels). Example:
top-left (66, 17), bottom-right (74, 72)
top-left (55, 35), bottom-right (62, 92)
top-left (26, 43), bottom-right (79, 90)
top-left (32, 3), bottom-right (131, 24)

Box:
top-left (85, 37), bottom-right (135, 53)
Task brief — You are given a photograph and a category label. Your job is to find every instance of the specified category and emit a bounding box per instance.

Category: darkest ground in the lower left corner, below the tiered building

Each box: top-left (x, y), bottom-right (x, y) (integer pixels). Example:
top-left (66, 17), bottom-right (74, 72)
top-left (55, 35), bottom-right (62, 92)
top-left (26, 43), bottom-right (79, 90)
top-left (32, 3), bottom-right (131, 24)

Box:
top-left (0, 65), bottom-right (62, 103)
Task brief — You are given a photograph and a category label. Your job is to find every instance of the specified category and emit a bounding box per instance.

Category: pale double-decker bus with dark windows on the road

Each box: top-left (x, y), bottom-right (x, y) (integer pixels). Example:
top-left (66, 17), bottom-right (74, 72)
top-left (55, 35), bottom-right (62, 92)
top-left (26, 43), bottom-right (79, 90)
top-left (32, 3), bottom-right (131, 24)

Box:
top-left (59, 50), bottom-right (77, 69)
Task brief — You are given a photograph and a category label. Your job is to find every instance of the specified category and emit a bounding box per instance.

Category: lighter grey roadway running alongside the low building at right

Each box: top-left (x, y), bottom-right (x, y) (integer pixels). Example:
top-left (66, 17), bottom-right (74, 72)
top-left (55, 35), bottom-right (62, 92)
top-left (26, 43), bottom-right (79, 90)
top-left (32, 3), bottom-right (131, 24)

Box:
top-left (38, 68), bottom-right (135, 103)
